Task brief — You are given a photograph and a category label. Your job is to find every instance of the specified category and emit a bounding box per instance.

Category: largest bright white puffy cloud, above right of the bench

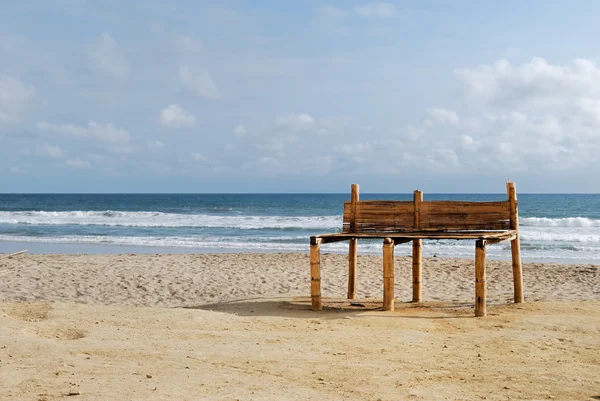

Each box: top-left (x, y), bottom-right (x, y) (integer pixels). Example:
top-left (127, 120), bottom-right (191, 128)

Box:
top-left (369, 58), bottom-right (600, 173)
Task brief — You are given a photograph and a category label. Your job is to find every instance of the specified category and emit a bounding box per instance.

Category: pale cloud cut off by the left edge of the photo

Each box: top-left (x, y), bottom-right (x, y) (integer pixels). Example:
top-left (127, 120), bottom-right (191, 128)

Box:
top-left (0, 74), bottom-right (35, 124)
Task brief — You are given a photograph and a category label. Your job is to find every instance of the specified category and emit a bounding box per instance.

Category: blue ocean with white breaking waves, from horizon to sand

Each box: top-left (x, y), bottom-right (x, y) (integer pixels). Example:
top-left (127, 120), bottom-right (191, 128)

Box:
top-left (0, 193), bottom-right (600, 264)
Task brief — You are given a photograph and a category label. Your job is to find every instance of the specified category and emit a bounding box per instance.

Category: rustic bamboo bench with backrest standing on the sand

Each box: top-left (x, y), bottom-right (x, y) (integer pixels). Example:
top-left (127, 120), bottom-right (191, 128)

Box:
top-left (310, 182), bottom-right (523, 316)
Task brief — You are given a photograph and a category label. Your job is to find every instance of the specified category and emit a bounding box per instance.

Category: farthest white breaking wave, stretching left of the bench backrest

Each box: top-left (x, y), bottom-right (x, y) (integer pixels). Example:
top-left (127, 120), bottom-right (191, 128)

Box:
top-left (0, 210), bottom-right (342, 230)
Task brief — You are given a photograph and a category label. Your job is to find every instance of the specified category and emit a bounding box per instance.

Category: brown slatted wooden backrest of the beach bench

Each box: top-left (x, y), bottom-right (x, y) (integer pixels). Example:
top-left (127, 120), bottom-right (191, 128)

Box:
top-left (342, 183), bottom-right (518, 233)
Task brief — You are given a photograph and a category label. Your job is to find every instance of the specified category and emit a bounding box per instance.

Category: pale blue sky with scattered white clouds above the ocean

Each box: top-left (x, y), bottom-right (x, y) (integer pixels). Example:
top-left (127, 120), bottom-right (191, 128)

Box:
top-left (0, 0), bottom-right (600, 193)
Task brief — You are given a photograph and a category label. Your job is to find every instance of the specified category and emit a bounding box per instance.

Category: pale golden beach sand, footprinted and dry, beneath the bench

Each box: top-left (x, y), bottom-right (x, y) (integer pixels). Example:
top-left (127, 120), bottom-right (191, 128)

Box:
top-left (0, 254), bottom-right (600, 400)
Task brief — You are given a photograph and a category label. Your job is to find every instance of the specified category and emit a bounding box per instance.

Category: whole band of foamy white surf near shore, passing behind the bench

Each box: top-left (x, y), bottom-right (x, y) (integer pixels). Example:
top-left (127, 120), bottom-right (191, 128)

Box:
top-left (0, 210), bottom-right (600, 261)
